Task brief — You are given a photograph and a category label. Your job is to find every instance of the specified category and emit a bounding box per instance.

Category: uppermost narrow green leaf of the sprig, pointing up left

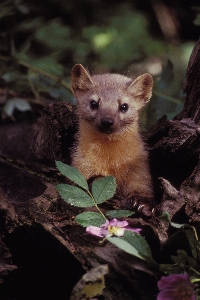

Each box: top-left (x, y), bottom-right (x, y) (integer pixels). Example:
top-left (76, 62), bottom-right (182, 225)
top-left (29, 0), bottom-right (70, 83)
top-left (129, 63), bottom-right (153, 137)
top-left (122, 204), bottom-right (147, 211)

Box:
top-left (56, 161), bottom-right (88, 190)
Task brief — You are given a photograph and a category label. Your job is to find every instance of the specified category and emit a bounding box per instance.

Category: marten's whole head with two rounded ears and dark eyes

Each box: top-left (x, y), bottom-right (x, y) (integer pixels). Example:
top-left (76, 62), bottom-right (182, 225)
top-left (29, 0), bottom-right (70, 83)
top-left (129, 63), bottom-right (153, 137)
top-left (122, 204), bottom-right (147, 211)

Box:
top-left (71, 64), bottom-right (153, 134)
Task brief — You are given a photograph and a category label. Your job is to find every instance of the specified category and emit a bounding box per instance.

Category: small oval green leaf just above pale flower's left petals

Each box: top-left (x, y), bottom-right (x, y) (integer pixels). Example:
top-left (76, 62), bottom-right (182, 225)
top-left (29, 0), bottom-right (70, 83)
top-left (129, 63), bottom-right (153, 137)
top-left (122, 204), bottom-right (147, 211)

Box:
top-left (74, 212), bottom-right (106, 227)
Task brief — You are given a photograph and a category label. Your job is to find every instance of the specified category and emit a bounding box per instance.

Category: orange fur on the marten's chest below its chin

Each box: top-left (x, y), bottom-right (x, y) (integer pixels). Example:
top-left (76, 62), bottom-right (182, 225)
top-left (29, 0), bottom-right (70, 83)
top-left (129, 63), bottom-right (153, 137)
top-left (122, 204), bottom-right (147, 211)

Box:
top-left (74, 122), bottom-right (144, 178)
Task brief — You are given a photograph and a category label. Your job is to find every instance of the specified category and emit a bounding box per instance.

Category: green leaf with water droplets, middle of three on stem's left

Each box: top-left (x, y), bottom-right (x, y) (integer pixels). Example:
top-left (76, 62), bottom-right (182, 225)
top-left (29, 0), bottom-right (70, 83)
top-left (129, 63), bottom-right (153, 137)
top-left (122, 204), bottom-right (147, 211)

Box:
top-left (56, 184), bottom-right (94, 207)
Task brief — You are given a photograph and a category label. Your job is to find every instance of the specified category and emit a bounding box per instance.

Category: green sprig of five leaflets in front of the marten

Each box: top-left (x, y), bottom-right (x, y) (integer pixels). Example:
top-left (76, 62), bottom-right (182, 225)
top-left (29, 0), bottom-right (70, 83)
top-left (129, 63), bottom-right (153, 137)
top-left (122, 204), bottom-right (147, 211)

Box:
top-left (56, 161), bottom-right (133, 227)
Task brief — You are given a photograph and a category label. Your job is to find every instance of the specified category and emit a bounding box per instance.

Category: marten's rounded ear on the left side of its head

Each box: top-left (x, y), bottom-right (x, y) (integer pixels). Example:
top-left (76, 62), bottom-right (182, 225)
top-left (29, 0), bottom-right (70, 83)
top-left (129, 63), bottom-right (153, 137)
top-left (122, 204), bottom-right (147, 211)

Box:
top-left (71, 64), bottom-right (94, 93)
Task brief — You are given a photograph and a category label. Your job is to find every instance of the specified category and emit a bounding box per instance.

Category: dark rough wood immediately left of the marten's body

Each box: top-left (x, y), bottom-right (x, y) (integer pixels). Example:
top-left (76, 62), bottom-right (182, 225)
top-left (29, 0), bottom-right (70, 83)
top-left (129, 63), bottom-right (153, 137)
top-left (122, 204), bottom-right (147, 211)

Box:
top-left (0, 103), bottom-right (77, 173)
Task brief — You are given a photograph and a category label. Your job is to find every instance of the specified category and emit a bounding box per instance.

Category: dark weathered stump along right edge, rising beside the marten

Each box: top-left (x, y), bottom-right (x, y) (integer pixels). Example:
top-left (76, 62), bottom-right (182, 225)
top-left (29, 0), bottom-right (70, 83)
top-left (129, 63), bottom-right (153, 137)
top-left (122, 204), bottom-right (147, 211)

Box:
top-left (149, 39), bottom-right (200, 222)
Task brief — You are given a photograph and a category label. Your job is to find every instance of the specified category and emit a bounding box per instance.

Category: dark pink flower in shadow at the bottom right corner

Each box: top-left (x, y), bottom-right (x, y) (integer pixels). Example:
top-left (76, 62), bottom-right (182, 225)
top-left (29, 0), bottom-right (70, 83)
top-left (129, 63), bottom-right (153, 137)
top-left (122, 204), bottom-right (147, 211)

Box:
top-left (157, 274), bottom-right (196, 300)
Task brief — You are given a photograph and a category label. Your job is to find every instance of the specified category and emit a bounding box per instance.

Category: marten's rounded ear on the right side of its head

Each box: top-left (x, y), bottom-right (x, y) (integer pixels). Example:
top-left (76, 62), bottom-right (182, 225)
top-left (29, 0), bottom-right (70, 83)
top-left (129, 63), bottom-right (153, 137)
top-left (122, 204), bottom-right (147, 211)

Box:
top-left (128, 73), bottom-right (153, 108)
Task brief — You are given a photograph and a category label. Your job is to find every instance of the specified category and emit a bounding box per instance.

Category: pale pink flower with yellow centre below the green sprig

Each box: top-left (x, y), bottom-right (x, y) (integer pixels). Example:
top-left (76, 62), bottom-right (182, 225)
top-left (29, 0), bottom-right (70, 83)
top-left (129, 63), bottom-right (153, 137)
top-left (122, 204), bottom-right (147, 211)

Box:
top-left (86, 219), bottom-right (141, 237)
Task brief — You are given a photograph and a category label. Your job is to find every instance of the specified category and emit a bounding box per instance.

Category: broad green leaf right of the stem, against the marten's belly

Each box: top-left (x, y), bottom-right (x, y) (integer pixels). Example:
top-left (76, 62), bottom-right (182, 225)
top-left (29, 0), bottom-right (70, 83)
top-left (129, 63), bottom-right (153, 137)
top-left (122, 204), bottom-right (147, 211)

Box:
top-left (92, 176), bottom-right (116, 204)
